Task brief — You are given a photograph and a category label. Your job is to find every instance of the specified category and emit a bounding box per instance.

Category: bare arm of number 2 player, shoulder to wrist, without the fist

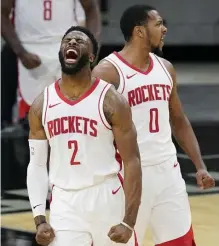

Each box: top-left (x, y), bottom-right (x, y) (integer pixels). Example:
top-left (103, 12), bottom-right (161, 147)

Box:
top-left (104, 88), bottom-right (142, 227)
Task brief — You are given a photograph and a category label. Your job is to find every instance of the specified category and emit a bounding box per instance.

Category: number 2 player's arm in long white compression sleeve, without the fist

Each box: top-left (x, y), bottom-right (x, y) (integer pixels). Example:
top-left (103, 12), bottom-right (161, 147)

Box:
top-left (27, 93), bottom-right (48, 226)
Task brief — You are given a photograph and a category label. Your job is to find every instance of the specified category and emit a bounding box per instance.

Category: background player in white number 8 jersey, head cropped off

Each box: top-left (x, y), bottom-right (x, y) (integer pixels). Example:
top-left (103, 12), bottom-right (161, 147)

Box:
top-left (1, 0), bottom-right (101, 118)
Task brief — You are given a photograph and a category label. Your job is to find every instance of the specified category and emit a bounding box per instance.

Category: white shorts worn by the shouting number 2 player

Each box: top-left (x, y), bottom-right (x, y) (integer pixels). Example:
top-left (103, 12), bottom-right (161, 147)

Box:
top-left (50, 176), bottom-right (137, 246)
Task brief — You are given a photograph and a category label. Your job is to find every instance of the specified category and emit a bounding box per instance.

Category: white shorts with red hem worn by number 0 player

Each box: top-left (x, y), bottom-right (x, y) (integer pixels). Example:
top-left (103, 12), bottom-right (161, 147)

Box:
top-left (135, 156), bottom-right (195, 246)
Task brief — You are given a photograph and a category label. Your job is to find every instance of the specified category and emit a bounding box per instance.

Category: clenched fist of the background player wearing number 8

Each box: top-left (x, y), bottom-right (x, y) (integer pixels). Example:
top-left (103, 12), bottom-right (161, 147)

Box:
top-left (19, 51), bottom-right (41, 69)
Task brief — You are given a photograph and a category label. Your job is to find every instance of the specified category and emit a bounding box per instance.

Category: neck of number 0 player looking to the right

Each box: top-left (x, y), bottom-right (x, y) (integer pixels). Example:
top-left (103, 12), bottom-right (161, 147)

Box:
top-left (120, 41), bottom-right (151, 70)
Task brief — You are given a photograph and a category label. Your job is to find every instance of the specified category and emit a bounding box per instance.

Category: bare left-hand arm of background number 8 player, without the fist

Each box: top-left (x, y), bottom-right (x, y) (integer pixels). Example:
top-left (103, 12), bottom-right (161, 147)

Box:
top-left (1, 0), bottom-right (24, 56)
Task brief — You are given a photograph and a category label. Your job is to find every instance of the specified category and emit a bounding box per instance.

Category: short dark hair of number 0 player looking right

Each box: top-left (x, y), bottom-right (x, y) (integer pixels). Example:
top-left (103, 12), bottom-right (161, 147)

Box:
top-left (120, 4), bottom-right (156, 41)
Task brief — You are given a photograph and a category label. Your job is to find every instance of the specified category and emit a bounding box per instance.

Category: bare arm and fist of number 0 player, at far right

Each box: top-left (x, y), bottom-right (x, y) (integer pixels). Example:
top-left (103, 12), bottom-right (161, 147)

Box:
top-left (162, 59), bottom-right (214, 188)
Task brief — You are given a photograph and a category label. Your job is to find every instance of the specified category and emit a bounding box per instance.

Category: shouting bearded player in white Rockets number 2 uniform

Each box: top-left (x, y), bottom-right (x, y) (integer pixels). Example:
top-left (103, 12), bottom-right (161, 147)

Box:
top-left (27, 27), bottom-right (141, 246)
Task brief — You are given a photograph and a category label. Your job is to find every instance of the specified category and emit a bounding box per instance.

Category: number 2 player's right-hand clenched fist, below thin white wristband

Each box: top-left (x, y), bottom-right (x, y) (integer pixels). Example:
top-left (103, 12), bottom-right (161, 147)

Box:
top-left (108, 224), bottom-right (132, 243)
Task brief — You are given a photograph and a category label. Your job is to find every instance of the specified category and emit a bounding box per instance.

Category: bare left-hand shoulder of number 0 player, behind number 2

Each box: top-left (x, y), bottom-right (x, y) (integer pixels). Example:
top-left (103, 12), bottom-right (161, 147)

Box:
top-left (92, 60), bottom-right (120, 89)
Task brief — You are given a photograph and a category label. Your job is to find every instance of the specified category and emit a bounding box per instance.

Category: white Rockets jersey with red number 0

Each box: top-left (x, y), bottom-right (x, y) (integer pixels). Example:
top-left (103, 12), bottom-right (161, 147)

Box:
top-left (104, 52), bottom-right (176, 166)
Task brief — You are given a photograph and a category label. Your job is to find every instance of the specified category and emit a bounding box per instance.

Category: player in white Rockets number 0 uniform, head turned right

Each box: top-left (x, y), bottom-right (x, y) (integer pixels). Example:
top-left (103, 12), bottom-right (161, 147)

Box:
top-left (93, 5), bottom-right (214, 246)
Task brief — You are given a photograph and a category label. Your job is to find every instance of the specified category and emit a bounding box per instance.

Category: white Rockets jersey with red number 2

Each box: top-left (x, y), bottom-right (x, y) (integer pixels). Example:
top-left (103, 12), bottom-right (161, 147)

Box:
top-left (42, 79), bottom-right (120, 190)
